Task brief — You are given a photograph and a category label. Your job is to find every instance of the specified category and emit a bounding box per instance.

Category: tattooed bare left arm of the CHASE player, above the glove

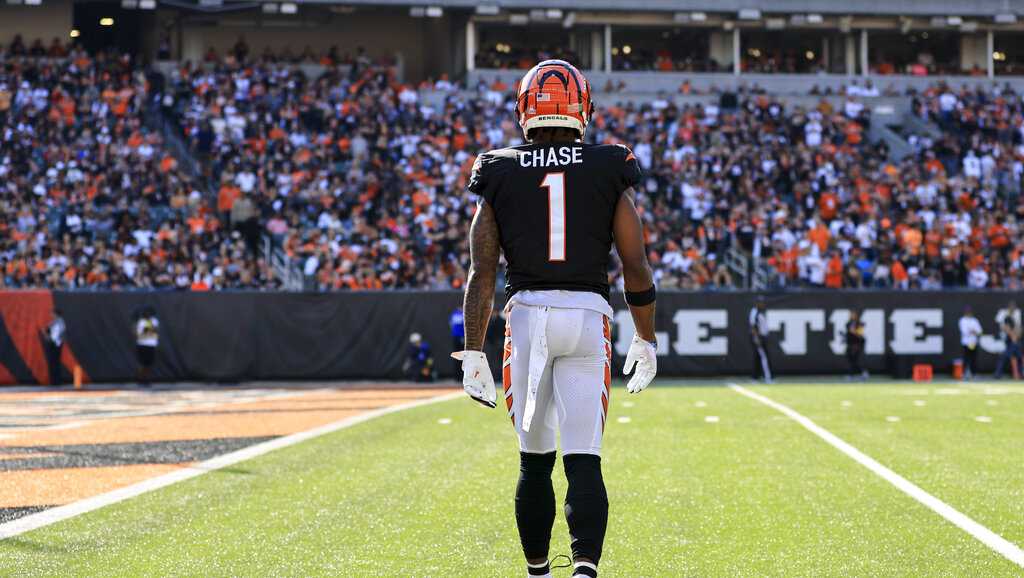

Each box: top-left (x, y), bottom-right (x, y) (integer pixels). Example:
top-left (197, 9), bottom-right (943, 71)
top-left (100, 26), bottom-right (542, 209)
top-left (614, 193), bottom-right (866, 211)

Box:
top-left (462, 202), bottom-right (501, 350)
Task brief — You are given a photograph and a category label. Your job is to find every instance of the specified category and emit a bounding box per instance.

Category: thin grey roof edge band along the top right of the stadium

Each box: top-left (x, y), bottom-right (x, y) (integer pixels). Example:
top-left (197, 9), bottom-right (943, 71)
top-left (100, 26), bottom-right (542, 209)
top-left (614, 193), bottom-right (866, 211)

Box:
top-left (298, 0), bottom-right (1024, 17)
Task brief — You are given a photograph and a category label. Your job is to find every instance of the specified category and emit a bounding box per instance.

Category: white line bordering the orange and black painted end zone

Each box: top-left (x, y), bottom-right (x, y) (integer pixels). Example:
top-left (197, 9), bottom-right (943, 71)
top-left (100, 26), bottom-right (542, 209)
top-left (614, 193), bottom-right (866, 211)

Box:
top-left (0, 391), bottom-right (463, 540)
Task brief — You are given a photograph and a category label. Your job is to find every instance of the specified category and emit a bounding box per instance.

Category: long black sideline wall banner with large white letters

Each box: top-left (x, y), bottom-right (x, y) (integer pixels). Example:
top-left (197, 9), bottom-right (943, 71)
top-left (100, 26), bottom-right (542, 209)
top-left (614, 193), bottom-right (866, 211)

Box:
top-left (0, 291), bottom-right (1022, 383)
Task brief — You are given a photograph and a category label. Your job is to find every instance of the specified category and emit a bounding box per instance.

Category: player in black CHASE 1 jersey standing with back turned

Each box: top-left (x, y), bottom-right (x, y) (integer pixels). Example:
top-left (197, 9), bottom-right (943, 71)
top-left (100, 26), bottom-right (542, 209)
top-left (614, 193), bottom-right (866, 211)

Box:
top-left (453, 60), bottom-right (657, 577)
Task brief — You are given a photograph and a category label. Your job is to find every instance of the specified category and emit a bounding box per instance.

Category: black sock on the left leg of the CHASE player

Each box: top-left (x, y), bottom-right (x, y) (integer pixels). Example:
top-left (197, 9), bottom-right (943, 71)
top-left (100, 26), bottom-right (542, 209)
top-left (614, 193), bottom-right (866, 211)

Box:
top-left (515, 452), bottom-right (555, 560)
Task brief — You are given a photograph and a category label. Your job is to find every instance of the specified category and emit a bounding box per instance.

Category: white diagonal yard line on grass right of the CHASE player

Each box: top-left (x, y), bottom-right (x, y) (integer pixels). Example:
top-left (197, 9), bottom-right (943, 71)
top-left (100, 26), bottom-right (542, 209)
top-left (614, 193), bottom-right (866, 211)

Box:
top-left (729, 383), bottom-right (1024, 568)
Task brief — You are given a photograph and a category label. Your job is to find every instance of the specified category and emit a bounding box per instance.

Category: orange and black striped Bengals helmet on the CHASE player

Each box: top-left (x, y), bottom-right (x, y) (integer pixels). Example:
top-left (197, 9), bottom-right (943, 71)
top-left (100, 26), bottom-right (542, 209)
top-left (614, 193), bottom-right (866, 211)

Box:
top-left (516, 60), bottom-right (594, 138)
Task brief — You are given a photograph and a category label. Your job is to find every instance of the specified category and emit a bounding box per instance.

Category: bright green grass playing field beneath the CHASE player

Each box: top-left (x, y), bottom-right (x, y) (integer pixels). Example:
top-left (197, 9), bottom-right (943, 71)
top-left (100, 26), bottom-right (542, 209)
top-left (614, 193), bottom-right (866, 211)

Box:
top-left (0, 381), bottom-right (1024, 577)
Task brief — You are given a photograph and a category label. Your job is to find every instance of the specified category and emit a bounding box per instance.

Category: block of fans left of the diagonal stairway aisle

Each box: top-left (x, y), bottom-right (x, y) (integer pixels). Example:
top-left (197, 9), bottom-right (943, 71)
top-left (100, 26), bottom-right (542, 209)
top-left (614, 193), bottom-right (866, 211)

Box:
top-left (0, 41), bottom-right (274, 289)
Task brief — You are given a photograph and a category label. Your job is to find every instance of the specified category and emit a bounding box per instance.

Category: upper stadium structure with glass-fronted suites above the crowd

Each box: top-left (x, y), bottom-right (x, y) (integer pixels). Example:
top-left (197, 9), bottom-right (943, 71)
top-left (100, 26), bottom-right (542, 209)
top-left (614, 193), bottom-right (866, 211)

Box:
top-left (6, 0), bottom-right (1024, 85)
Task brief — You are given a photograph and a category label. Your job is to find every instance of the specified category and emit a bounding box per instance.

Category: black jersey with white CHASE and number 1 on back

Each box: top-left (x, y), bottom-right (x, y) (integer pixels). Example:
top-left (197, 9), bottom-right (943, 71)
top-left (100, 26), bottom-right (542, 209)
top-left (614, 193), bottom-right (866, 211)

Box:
top-left (469, 142), bottom-right (640, 299)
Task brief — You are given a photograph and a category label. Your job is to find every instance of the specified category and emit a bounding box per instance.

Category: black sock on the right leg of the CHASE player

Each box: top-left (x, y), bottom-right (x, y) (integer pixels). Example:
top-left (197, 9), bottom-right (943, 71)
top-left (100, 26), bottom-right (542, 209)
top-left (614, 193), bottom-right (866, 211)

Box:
top-left (562, 454), bottom-right (608, 565)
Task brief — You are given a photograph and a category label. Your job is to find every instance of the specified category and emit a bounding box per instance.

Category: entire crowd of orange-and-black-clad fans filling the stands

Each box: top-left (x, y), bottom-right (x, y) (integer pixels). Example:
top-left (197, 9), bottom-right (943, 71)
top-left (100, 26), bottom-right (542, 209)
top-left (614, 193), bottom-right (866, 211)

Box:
top-left (0, 36), bottom-right (1024, 290)
